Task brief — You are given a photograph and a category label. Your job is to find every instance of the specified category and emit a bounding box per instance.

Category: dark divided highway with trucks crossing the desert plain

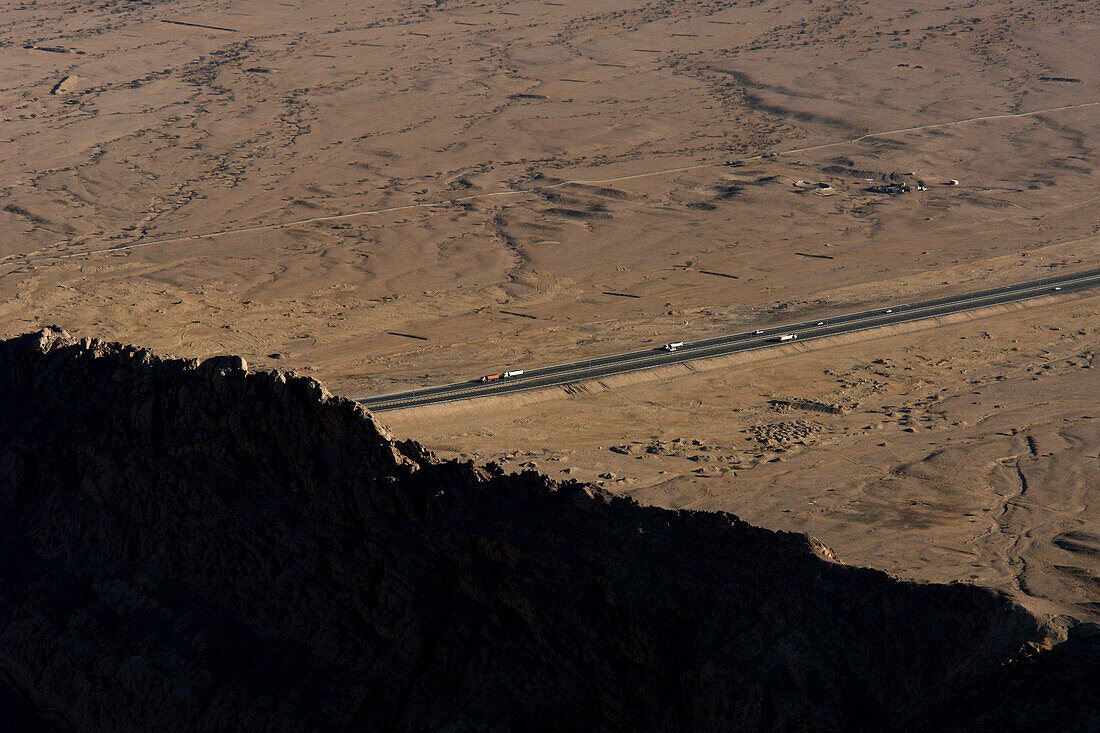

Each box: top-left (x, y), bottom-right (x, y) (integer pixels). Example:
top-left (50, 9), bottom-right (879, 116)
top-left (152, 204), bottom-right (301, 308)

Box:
top-left (359, 270), bottom-right (1100, 412)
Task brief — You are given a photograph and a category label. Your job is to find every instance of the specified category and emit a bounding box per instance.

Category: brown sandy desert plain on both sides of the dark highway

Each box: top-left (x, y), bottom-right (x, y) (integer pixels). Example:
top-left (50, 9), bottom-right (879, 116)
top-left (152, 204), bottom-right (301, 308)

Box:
top-left (0, 0), bottom-right (1100, 617)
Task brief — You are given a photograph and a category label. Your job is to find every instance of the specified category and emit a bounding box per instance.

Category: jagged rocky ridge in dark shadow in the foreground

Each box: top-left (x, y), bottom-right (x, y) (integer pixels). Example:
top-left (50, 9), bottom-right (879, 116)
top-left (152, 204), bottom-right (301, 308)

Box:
top-left (0, 329), bottom-right (1095, 731)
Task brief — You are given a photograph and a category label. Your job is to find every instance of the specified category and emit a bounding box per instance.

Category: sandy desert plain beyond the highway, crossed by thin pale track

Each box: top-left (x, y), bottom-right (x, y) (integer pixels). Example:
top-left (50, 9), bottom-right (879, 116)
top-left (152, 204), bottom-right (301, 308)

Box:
top-left (0, 0), bottom-right (1100, 394)
